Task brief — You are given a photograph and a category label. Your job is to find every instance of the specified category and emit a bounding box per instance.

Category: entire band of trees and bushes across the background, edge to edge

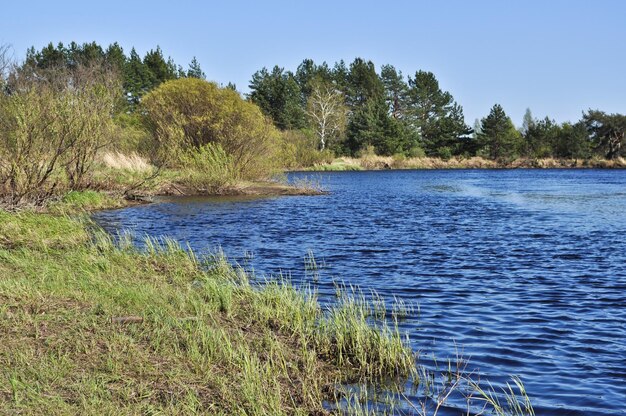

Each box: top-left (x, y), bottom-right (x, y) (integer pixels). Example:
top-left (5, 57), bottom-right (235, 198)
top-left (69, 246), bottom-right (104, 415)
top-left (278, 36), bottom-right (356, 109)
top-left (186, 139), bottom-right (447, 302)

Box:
top-left (0, 42), bottom-right (626, 202)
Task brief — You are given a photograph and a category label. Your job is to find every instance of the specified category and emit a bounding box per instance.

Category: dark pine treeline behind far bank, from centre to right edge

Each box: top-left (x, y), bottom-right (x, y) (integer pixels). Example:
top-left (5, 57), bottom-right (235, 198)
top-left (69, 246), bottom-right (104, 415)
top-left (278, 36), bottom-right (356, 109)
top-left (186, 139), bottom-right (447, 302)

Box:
top-left (248, 58), bottom-right (626, 160)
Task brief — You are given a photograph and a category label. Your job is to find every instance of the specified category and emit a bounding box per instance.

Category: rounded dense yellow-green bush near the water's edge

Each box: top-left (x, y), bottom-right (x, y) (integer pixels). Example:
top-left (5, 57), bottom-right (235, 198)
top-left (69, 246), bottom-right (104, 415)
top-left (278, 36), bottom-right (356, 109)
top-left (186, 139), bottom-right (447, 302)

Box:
top-left (142, 78), bottom-right (279, 179)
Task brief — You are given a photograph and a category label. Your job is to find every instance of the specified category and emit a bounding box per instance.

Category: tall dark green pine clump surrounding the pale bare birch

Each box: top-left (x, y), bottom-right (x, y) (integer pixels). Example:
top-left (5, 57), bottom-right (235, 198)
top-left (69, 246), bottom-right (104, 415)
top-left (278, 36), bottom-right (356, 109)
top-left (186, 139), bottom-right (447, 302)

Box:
top-left (250, 58), bottom-right (469, 159)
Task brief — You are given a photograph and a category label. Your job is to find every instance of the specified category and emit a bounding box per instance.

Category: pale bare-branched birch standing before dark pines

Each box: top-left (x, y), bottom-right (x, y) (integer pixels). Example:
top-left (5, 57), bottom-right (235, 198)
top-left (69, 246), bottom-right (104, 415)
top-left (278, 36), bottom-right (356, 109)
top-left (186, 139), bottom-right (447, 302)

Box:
top-left (307, 82), bottom-right (347, 150)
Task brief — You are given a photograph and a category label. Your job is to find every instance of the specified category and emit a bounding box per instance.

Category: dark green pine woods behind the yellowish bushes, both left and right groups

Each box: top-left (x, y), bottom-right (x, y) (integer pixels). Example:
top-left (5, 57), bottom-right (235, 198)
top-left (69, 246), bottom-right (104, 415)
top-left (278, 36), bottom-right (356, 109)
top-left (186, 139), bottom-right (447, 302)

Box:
top-left (11, 42), bottom-right (626, 159)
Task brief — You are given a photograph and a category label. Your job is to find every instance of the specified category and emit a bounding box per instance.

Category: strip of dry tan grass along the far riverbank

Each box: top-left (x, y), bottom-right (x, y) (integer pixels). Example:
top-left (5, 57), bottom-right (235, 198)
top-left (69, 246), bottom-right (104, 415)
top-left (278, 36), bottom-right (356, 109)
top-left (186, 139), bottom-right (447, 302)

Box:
top-left (303, 156), bottom-right (626, 172)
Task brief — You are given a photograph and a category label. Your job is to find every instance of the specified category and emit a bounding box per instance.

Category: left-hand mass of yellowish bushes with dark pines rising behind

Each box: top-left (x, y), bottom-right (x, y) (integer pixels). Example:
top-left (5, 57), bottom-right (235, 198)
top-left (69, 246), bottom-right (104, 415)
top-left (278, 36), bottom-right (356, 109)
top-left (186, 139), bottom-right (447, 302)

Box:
top-left (0, 43), bottom-right (294, 205)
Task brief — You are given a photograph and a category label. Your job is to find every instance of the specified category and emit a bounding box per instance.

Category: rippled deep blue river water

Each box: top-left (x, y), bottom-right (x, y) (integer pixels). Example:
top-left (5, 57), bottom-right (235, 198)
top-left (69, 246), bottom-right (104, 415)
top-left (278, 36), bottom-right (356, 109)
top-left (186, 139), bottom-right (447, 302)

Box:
top-left (96, 170), bottom-right (626, 416)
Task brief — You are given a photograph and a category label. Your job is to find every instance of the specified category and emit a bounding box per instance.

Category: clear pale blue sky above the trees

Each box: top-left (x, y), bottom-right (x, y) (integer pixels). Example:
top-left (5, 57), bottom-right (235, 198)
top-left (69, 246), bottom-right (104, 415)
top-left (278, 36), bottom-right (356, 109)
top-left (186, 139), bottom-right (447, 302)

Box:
top-left (0, 0), bottom-right (626, 125)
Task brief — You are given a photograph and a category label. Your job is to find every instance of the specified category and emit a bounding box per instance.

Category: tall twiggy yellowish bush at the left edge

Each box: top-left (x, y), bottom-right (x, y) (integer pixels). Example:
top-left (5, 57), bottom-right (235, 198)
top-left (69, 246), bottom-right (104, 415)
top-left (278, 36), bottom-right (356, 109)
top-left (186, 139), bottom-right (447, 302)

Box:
top-left (0, 64), bottom-right (119, 204)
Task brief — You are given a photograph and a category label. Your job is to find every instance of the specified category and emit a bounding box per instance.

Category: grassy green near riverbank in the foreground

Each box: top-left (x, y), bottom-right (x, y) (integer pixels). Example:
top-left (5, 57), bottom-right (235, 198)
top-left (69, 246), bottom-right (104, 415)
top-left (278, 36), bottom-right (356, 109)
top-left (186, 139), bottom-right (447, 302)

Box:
top-left (0, 210), bottom-right (415, 414)
